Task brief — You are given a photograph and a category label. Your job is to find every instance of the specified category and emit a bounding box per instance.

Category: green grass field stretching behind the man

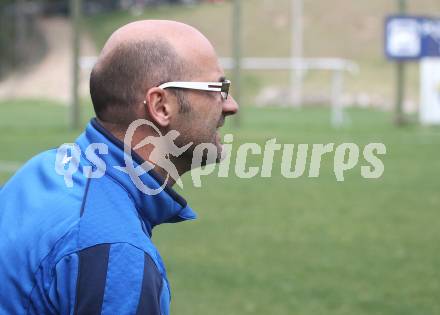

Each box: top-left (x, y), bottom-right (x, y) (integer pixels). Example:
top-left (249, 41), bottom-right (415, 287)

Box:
top-left (0, 101), bottom-right (440, 315)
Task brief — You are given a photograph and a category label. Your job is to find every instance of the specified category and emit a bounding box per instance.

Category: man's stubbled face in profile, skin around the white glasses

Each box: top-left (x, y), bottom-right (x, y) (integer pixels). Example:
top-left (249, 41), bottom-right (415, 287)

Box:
top-left (169, 56), bottom-right (238, 165)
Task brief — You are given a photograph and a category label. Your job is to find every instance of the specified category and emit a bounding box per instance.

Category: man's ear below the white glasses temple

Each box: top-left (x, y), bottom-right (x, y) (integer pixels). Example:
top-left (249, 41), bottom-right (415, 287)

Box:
top-left (144, 87), bottom-right (173, 127)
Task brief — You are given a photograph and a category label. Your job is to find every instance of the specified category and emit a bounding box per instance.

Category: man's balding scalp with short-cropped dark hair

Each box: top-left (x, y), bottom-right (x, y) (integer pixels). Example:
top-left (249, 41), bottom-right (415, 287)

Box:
top-left (90, 20), bottom-right (215, 125)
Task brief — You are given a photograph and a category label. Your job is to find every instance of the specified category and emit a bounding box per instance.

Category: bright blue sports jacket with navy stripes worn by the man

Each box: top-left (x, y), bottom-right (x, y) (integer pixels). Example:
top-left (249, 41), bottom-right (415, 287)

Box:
top-left (0, 120), bottom-right (195, 315)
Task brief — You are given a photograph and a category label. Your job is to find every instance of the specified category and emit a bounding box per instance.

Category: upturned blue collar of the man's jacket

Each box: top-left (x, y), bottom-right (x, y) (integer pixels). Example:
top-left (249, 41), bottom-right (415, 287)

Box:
top-left (76, 118), bottom-right (196, 236)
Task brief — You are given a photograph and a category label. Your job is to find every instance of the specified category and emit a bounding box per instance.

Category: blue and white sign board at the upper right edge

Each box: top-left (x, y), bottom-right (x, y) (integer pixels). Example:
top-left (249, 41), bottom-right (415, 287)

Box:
top-left (385, 15), bottom-right (440, 60)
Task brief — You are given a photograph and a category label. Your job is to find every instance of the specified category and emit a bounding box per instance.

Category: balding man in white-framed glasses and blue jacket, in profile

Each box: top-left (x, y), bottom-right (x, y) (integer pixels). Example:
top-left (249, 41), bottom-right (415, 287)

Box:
top-left (0, 21), bottom-right (238, 315)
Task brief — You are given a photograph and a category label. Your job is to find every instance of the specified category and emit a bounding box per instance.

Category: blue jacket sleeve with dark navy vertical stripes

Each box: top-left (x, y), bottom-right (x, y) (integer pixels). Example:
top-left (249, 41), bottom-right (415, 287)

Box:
top-left (52, 243), bottom-right (168, 315)
